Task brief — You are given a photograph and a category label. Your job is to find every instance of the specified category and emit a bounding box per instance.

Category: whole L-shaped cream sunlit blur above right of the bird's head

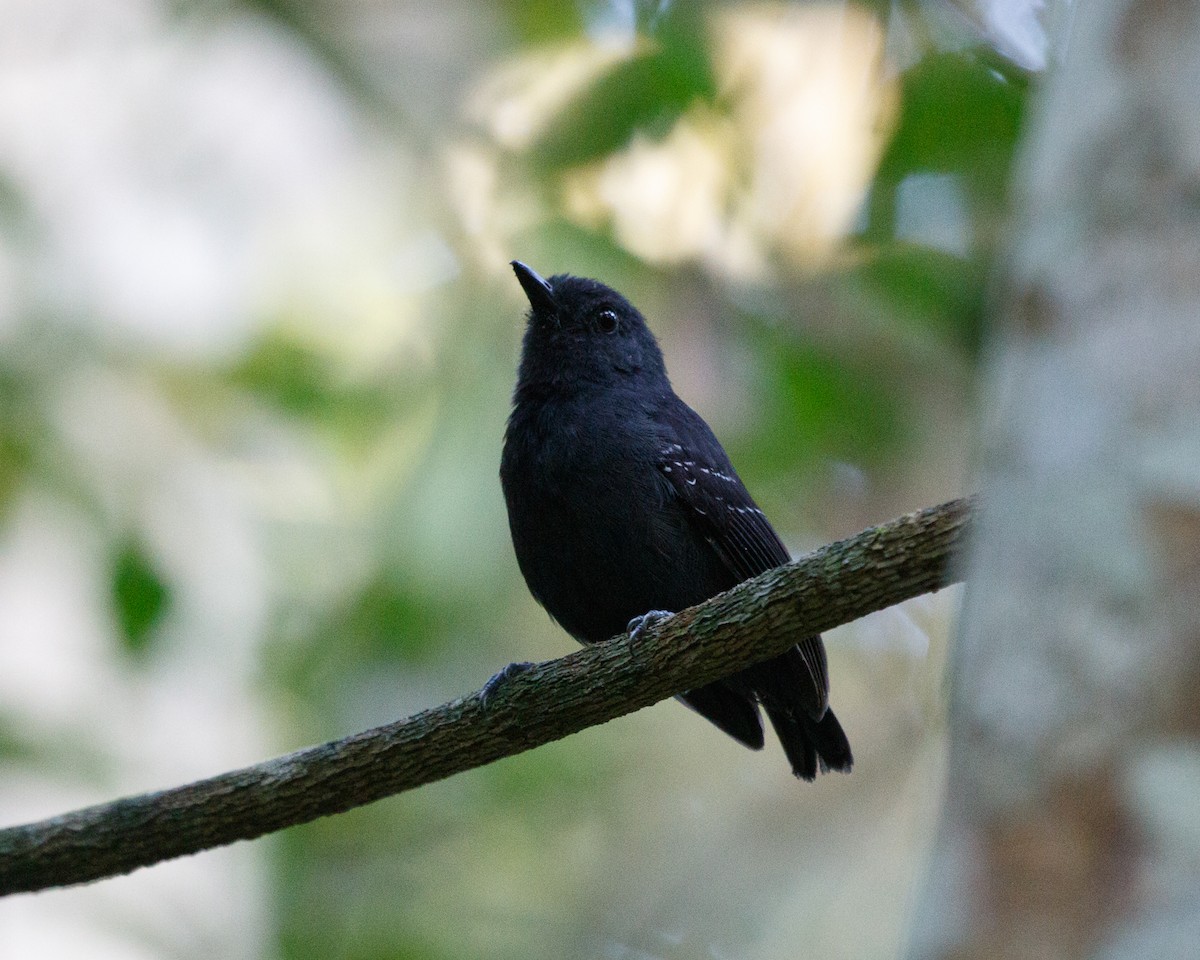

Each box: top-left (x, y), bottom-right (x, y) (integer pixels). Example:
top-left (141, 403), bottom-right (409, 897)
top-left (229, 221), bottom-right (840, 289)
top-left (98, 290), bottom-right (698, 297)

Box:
top-left (549, 5), bottom-right (898, 278)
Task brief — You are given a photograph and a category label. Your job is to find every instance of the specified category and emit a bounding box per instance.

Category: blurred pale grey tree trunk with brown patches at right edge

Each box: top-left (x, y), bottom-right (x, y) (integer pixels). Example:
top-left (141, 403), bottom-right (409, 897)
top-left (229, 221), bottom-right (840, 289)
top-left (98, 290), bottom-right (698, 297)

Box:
top-left (910, 0), bottom-right (1200, 960)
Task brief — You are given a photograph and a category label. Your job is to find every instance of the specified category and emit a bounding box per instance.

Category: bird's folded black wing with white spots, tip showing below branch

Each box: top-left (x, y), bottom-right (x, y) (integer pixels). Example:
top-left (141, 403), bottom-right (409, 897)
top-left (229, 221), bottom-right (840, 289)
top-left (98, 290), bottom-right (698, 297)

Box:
top-left (658, 401), bottom-right (829, 718)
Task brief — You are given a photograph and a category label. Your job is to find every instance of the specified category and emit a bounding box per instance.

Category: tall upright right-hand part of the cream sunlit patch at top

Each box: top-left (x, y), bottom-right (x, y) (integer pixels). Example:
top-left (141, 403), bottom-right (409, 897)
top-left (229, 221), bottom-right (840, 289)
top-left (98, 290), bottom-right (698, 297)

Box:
top-left (713, 5), bottom-right (898, 264)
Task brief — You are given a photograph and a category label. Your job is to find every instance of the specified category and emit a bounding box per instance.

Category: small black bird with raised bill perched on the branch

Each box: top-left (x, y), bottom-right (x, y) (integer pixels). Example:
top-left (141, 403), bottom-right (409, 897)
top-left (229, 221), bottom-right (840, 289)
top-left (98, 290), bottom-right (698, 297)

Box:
top-left (500, 260), bottom-right (852, 780)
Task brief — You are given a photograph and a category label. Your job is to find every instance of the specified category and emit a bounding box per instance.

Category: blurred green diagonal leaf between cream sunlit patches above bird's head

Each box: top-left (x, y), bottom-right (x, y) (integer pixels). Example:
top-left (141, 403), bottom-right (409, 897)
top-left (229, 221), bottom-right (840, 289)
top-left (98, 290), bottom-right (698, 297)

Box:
top-left (532, 18), bottom-right (716, 169)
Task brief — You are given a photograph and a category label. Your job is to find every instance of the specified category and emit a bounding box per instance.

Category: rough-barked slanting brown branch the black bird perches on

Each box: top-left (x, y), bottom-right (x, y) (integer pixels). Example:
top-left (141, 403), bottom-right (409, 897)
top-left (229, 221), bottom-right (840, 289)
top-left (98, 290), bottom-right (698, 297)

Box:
top-left (0, 499), bottom-right (974, 895)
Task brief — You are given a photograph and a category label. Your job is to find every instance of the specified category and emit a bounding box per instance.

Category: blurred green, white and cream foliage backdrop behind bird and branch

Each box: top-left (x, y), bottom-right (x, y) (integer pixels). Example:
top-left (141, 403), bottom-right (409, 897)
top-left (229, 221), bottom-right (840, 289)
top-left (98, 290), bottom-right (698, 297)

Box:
top-left (0, 0), bottom-right (1051, 960)
